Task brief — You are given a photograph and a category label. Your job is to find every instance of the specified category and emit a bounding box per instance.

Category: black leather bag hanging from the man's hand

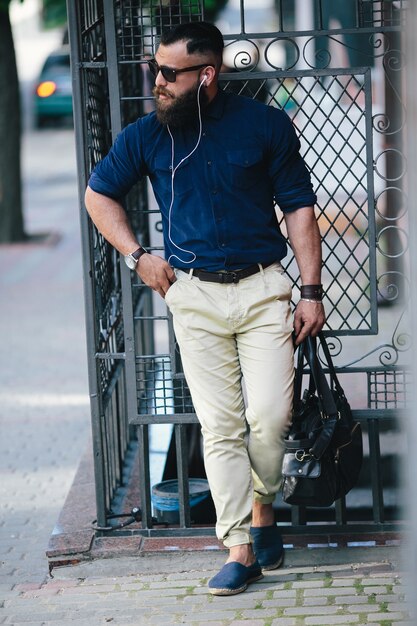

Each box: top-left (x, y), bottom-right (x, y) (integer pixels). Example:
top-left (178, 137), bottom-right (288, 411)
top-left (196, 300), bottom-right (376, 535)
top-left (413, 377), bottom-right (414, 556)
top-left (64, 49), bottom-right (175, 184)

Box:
top-left (282, 334), bottom-right (363, 507)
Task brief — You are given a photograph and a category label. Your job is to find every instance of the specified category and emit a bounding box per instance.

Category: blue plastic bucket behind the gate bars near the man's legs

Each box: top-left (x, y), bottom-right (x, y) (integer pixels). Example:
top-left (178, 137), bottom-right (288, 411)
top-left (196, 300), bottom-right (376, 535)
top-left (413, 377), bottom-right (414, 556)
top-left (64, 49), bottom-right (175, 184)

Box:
top-left (151, 478), bottom-right (212, 524)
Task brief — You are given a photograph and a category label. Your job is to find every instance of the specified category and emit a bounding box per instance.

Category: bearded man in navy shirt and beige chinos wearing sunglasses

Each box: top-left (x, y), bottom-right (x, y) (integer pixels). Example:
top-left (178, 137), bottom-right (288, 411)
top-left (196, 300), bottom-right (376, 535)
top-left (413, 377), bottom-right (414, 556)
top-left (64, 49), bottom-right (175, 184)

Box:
top-left (85, 22), bottom-right (325, 595)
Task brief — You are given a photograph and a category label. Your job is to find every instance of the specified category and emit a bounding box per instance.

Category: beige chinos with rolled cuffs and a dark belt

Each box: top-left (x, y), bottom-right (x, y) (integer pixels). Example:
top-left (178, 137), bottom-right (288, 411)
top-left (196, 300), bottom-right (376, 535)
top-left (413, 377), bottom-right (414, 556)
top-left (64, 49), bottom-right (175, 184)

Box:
top-left (166, 263), bottom-right (294, 548)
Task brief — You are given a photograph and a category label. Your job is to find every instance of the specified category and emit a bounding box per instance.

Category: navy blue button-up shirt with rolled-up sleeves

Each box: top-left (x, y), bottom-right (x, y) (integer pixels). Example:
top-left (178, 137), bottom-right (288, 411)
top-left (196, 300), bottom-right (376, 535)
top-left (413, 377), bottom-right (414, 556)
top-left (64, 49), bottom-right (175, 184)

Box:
top-left (89, 90), bottom-right (316, 271)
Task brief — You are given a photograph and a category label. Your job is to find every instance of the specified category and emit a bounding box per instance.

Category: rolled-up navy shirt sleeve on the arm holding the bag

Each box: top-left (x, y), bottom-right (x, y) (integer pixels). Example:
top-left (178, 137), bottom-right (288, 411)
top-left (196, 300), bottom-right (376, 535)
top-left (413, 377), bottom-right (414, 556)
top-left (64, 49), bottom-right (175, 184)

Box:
top-left (267, 107), bottom-right (317, 213)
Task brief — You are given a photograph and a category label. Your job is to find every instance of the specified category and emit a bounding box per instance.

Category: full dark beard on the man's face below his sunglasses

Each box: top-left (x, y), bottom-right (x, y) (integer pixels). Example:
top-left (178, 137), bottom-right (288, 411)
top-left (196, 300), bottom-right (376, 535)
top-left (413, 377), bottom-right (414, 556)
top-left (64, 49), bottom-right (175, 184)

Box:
top-left (153, 85), bottom-right (207, 128)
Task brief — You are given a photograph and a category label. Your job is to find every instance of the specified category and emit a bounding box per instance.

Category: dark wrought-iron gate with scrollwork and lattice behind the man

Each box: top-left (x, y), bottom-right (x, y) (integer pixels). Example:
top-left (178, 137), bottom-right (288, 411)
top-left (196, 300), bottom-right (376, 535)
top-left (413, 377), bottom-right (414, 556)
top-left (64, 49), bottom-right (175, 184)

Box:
top-left (68, 0), bottom-right (410, 535)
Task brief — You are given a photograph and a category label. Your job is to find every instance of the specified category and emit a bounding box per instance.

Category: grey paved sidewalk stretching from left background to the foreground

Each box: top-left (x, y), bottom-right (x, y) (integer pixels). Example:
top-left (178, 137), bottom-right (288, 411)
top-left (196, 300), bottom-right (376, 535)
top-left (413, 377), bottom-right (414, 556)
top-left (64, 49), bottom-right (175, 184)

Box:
top-left (0, 130), bottom-right (410, 626)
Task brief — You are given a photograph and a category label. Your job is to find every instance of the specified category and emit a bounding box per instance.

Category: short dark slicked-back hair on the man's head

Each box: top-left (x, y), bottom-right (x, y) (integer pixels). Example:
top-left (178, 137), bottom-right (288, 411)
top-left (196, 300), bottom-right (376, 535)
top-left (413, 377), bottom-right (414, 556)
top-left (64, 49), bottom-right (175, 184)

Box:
top-left (161, 22), bottom-right (224, 61)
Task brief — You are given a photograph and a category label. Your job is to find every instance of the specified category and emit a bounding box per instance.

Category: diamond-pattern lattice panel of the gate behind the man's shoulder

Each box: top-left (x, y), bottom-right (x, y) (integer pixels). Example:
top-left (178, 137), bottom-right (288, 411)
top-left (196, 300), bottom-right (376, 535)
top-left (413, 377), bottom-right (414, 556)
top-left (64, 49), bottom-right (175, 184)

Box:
top-left (225, 71), bottom-right (376, 334)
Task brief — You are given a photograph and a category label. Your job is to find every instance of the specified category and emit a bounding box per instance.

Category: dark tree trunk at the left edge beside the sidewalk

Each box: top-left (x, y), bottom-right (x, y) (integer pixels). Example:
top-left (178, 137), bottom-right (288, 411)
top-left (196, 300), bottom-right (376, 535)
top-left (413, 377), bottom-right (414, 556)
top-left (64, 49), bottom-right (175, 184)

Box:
top-left (0, 10), bottom-right (26, 243)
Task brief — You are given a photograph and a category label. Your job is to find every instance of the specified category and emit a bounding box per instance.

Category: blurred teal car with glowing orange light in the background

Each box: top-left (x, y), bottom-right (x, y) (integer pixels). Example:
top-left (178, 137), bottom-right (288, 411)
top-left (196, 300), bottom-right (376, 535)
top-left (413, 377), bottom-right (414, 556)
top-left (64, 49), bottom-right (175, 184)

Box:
top-left (34, 45), bottom-right (72, 128)
